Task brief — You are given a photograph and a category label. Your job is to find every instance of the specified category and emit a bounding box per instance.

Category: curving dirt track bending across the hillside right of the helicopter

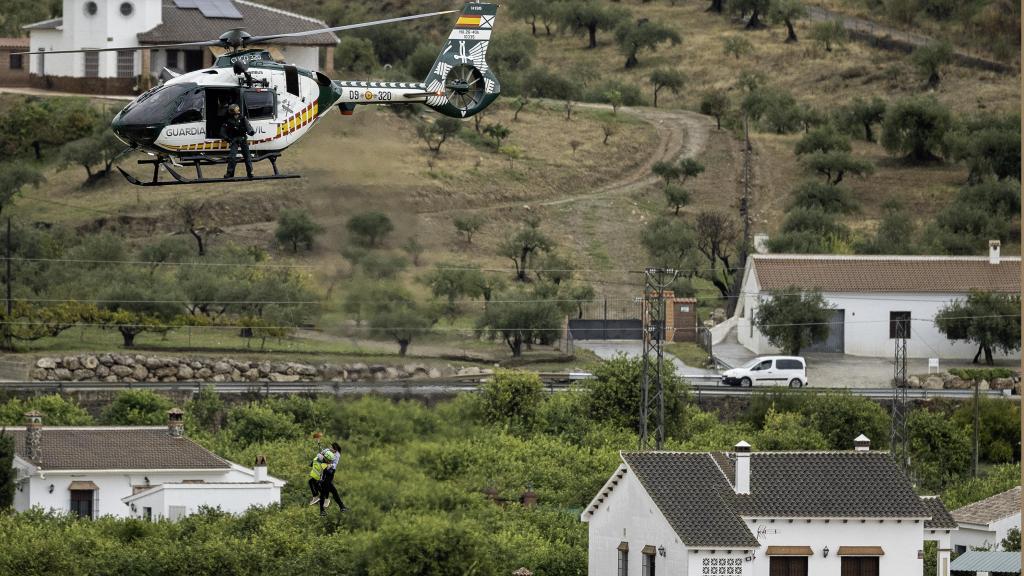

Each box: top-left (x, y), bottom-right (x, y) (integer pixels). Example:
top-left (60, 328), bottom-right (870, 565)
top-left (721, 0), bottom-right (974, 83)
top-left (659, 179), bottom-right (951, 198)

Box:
top-left (419, 102), bottom-right (715, 214)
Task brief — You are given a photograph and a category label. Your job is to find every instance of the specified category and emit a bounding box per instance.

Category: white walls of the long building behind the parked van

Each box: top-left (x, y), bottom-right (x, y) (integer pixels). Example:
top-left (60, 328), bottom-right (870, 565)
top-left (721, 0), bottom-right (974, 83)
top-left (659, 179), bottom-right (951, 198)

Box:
top-left (735, 265), bottom-right (1020, 360)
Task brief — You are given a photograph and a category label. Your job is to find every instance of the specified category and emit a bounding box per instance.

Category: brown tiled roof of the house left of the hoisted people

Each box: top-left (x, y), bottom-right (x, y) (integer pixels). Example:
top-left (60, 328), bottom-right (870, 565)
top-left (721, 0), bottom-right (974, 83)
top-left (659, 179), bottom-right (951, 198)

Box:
top-left (7, 426), bottom-right (230, 470)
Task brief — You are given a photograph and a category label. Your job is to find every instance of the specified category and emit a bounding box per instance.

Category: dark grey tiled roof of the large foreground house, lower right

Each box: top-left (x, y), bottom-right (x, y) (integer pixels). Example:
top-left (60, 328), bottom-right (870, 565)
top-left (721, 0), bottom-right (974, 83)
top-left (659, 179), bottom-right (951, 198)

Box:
top-left (622, 452), bottom-right (941, 548)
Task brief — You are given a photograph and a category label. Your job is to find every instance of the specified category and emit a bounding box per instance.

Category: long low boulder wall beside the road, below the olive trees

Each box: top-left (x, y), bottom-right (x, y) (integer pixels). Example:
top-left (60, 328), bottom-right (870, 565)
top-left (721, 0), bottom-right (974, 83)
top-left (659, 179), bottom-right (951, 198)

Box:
top-left (29, 354), bottom-right (489, 382)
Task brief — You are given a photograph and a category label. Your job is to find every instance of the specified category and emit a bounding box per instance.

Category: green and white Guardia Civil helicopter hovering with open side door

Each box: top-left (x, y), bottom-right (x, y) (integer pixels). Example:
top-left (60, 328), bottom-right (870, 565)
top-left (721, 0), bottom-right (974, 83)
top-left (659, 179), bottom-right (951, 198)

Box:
top-left (22, 2), bottom-right (501, 187)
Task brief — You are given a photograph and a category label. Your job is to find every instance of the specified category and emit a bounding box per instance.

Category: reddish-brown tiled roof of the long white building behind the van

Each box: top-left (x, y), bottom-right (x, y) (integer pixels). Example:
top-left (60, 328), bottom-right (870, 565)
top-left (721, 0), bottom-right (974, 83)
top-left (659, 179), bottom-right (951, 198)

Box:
top-left (752, 254), bottom-right (1021, 293)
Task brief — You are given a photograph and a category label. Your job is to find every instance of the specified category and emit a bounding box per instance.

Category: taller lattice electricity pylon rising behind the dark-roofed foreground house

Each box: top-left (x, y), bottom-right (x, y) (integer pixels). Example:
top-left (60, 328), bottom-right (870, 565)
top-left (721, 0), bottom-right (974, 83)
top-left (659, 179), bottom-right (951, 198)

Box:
top-left (640, 269), bottom-right (679, 450)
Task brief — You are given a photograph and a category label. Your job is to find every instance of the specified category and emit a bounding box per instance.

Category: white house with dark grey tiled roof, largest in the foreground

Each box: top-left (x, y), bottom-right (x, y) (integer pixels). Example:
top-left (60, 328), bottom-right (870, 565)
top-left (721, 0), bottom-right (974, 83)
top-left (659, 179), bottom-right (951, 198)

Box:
top-left (581, 437), bottom-right (956, 576)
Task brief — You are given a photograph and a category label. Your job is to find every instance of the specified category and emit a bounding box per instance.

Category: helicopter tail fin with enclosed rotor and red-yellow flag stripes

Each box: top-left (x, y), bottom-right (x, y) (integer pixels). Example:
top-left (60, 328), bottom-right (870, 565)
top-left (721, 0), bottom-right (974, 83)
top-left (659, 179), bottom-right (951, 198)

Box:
top-left (424, 2), bottom-right (501, 118)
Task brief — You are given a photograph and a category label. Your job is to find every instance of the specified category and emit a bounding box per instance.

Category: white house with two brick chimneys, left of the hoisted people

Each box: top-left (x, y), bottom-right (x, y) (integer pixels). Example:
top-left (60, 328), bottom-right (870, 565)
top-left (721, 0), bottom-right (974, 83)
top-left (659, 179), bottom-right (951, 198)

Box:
top-left (6, 410), bottom-right (285, 520)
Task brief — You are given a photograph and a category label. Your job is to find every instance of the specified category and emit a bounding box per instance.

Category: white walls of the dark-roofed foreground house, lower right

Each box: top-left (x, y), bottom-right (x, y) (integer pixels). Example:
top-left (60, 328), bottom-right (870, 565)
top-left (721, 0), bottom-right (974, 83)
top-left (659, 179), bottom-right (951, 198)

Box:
top-left (581, 445), bottom-right (950, 576)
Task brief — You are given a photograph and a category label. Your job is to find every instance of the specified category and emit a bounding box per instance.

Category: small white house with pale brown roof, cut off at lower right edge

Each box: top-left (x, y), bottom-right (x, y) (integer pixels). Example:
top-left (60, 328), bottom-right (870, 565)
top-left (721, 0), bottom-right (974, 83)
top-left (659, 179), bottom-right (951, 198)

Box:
top-left (951, 486), bottom-right (1021, 552)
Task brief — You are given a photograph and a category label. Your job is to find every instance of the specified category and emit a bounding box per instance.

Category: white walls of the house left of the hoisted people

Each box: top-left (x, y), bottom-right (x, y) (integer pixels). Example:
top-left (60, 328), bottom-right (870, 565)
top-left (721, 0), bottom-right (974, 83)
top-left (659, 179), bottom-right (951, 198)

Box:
top-left (14, 448), bottom-right (285, 518)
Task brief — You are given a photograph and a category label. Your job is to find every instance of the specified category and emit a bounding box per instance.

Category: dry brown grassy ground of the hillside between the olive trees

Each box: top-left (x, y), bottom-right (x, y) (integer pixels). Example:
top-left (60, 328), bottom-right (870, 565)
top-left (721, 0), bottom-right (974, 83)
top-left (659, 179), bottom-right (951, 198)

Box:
top-left (0, 2), bottom-right (1020, 353)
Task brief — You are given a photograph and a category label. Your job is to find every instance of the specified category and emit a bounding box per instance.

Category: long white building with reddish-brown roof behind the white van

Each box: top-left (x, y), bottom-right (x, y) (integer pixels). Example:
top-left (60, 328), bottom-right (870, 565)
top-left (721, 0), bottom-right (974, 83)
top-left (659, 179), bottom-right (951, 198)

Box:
top-left (731, 241), bottom-right (1021, 359)
